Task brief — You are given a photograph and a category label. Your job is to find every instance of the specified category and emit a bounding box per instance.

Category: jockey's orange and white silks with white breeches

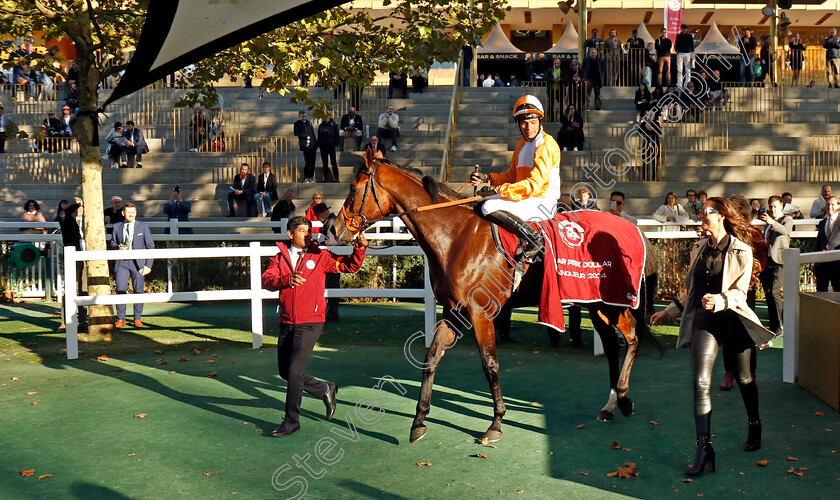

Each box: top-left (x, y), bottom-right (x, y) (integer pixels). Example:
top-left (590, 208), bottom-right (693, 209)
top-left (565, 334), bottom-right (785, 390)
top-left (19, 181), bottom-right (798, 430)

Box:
top-left (482, 130), bottom-right (560, 221)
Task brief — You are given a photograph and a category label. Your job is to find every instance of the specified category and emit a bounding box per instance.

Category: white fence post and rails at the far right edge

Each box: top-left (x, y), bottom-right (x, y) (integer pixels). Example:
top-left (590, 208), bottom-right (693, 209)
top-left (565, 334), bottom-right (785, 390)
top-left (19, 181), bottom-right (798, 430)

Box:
top-left (782, 248), bottom-right (840, 384)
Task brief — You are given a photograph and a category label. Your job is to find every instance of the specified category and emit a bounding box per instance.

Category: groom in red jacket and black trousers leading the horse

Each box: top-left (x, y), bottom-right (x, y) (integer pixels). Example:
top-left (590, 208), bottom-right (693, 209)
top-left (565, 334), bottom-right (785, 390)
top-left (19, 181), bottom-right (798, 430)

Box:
top-left (262, 216), bottom-right (367, 437)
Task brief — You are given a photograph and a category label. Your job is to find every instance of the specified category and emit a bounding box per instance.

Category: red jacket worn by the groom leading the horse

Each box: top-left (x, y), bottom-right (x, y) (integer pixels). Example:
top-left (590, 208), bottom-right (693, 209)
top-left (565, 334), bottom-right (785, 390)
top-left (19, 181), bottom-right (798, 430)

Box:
top-left (262, 242), bottom-right (365, 325)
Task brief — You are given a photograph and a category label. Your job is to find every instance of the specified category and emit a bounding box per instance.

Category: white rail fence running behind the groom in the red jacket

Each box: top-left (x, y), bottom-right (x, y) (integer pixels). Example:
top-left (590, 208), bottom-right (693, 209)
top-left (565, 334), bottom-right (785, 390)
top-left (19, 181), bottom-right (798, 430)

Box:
top-left (64, 241), bottom-right (436, 359)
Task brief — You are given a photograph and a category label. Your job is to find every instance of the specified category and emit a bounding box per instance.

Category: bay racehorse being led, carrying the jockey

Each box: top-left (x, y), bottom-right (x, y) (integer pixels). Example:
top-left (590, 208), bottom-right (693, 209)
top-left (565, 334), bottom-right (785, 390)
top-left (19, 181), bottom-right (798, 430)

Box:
top-left (334, 151), bottom-right (645, 443)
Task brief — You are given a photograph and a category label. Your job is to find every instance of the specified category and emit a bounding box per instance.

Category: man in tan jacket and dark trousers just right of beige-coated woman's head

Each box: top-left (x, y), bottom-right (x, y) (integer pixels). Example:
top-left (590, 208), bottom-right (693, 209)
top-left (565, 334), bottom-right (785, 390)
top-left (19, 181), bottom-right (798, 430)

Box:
top-left (759, 195), bottom-right (793, 335)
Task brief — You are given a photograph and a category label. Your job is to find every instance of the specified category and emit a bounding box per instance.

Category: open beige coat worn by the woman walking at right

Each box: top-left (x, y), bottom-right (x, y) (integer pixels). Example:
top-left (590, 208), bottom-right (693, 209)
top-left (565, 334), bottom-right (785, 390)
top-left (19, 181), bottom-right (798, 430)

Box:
top-left (665, 236), bottom-right (776, 348)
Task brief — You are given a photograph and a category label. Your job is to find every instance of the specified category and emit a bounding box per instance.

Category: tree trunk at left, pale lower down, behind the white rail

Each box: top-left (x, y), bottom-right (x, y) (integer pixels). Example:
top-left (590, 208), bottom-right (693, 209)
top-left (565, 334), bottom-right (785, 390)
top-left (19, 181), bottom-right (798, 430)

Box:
top-left (68, 11), bottom-right (114, 338)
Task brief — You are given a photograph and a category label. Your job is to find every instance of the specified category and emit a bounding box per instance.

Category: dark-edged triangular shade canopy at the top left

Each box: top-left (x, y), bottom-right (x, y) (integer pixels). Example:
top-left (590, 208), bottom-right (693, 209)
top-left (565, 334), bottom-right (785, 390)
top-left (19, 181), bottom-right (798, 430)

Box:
top-left (105, 0), bottom-right (346, 105)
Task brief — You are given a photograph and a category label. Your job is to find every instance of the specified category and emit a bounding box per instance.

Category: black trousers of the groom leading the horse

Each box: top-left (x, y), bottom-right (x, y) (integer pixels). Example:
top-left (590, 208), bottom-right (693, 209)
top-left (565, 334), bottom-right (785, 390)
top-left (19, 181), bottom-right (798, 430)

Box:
top-left (277, 323), bottom-right (329, 425)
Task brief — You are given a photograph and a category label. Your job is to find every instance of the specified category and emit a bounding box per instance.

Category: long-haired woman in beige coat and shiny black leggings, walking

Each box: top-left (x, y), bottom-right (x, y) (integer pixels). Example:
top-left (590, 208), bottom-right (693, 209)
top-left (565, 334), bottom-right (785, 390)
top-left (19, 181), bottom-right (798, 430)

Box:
top-left (650, 197), bottom-right (775, 476)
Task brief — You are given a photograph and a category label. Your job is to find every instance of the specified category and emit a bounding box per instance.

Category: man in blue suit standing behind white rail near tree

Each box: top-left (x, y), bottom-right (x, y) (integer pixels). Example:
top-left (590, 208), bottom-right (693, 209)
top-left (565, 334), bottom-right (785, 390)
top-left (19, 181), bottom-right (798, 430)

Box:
top-left (108, 203), bottom-right (155, 328)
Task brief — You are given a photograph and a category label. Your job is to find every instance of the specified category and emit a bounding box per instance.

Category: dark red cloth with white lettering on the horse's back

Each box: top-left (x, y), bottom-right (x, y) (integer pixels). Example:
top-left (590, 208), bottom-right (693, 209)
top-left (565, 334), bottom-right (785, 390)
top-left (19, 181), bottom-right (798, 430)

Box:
top-left (499, 210), bottom-right (645, 332)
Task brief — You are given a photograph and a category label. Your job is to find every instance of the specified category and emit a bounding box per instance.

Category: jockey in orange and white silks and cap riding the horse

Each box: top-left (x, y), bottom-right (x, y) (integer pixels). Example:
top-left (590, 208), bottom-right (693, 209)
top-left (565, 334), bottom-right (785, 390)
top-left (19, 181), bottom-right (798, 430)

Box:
top-left (470, 95), bottom-right (560, 262)
